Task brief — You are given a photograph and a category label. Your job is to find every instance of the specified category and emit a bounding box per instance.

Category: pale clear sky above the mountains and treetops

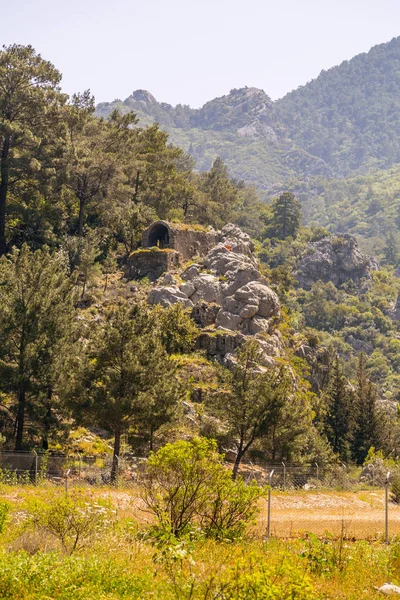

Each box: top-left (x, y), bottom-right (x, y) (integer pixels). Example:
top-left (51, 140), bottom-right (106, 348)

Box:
top-left (0, 0), bottom-right (400, 107)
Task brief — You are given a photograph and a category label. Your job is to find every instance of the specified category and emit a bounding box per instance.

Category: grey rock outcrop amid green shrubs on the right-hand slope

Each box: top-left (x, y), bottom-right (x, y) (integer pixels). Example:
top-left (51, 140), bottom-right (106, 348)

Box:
top-left (295, 234), bottom-right (378, 290)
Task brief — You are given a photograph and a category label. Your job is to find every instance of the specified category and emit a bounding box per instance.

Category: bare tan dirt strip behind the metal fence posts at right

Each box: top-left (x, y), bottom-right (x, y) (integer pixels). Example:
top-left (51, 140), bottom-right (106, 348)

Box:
top-left (257, 490), bottom-right (400, 539)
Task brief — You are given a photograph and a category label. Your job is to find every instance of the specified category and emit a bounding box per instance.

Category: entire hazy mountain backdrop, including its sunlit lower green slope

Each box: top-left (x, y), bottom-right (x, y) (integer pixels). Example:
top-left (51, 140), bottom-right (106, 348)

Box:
top-left (97, 37), bottom-right (400, 255)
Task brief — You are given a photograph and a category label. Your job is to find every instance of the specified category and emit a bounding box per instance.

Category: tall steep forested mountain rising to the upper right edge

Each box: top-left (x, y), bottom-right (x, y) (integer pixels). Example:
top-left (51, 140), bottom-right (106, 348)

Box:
top-left (274, 37), bottom-right (400, 175)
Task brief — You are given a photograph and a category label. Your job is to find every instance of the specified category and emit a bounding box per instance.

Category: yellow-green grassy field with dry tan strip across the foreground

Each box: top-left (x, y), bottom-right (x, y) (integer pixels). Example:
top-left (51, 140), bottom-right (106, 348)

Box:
top-left (0, 482), bottom-right (400, 600)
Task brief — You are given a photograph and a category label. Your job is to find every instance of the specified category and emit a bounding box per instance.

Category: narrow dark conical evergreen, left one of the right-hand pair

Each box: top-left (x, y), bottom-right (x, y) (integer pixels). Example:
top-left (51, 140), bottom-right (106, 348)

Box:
top-left (325, 356), bottom-right (352, 461)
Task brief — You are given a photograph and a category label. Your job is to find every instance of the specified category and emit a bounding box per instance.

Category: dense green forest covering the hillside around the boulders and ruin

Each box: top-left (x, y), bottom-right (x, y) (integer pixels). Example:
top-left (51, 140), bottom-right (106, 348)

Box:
top-left (0, 39), bottom-right (400, 477)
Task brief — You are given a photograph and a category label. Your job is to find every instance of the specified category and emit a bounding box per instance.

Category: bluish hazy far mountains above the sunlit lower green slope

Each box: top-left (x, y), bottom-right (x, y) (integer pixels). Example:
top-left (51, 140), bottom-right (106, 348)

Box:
top-left (97, 37), bottom-right (400, 196)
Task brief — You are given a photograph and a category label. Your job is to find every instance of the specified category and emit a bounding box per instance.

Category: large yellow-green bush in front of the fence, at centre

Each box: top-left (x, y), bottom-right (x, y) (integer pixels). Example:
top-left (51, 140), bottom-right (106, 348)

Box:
top-left (142, 438), bottom-right (264, 538)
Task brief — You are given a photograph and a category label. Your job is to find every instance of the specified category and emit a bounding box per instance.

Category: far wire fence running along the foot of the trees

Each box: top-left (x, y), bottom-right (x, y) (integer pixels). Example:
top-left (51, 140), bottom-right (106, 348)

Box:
top-left (0, 451), bottom-right (386, 491)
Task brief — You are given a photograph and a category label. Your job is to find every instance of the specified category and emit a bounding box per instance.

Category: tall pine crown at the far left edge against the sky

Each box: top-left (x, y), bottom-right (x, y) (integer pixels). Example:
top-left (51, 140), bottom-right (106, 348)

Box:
top-left (0, 44), bottom-right (65, 256)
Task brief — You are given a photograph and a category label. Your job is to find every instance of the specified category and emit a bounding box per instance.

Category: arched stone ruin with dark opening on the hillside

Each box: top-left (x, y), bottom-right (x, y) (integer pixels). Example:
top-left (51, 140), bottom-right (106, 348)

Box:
top-left (126, 221), bottom-right (217, 281)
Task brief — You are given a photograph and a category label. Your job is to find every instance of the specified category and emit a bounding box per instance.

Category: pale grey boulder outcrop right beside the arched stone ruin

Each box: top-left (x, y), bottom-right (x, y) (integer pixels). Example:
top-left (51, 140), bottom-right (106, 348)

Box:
top-left (148, 224), bottom-right (282, 364)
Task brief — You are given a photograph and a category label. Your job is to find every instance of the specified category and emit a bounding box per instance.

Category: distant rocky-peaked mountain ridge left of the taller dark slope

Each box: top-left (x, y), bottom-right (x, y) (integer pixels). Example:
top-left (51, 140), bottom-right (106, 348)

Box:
top-left (96, 87), bottom-right (332, 190)
